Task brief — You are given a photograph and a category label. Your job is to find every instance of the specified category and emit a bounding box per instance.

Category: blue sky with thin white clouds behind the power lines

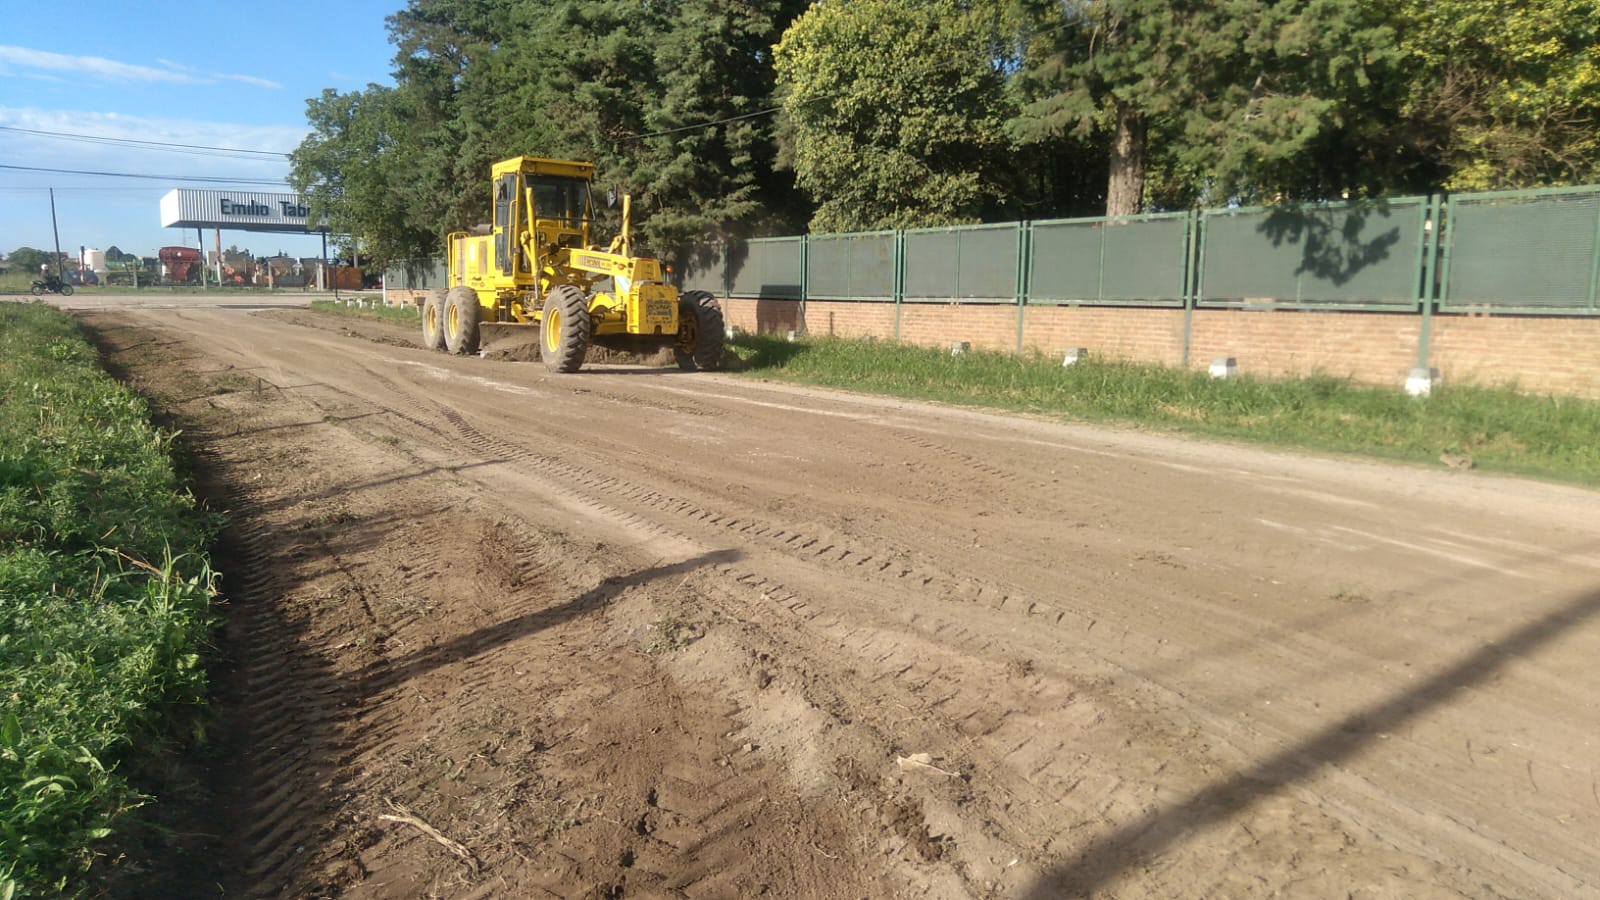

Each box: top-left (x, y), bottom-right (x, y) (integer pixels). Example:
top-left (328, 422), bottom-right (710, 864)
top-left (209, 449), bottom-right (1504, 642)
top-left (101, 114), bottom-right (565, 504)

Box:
top-left (0, 0), bottom-right (405, 256)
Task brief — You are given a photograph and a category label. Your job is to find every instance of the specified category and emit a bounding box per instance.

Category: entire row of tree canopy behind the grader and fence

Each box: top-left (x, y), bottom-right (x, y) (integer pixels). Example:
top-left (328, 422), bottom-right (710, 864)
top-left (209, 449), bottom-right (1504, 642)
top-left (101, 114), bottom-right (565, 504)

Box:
top-left (291, 0), bottom-right (1600, 261)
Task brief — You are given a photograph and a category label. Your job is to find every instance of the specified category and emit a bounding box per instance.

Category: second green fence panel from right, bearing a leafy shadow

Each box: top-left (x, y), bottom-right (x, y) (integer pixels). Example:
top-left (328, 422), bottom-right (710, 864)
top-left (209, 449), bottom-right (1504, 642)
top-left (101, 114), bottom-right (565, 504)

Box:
top-left (1198, 197), bottom-right (1427, 307)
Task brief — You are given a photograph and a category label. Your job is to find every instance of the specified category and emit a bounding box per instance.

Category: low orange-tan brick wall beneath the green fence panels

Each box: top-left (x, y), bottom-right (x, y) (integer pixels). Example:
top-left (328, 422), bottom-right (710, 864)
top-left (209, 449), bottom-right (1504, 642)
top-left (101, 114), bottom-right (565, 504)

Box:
top-left (722, 298), bottom-right (1600, 399)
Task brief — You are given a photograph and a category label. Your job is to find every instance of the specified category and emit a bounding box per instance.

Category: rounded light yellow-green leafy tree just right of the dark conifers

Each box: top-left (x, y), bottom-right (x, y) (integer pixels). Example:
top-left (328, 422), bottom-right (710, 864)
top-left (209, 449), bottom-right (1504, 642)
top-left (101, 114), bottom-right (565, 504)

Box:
top-left (774, 0), bottom-right (1011, 231)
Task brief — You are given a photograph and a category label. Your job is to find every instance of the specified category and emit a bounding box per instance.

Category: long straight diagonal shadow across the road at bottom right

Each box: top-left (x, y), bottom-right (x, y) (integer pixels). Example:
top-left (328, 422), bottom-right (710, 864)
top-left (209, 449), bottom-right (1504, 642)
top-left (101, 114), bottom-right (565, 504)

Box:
top-left (1022, 591), bottom-right (1600, 900)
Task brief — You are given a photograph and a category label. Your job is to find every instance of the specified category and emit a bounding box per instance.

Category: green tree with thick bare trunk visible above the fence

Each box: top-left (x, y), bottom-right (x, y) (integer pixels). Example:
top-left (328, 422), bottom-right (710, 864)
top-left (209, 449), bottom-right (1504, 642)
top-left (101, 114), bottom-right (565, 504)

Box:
top-left (1013, 0), bottom-right (1398, 215)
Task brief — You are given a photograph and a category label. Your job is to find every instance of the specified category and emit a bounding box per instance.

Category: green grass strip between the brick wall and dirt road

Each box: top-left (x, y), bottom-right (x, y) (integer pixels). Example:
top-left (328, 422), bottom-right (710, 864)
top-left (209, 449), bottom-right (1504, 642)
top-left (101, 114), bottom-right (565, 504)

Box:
top-left (730, 335), bottom-right (1600, 485)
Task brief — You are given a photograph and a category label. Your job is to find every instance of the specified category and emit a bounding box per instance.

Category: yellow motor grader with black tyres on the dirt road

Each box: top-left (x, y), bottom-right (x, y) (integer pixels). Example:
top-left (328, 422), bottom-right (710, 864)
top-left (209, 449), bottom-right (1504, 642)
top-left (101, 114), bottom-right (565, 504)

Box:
top-left (422, 157), bottom-right (723, 372)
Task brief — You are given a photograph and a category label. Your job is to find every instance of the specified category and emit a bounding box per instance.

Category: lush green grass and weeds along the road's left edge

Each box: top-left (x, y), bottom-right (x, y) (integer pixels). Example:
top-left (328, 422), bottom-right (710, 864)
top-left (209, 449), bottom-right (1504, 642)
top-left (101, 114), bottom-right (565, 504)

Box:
top-left (0, 303), bottom-right (216, 897)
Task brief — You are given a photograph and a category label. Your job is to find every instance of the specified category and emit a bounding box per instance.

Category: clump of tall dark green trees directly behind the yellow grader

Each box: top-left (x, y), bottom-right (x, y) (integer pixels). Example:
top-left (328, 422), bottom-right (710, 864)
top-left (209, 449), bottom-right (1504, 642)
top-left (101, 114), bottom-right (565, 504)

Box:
top-left (294, 0), bottom-right (805, 259)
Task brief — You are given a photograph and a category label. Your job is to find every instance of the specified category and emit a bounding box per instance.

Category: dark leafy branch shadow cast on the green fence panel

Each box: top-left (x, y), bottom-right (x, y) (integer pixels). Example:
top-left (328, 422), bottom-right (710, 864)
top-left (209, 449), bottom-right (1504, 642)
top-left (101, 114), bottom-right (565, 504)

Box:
top-left (1256, 200), bottom-right (1400, 285)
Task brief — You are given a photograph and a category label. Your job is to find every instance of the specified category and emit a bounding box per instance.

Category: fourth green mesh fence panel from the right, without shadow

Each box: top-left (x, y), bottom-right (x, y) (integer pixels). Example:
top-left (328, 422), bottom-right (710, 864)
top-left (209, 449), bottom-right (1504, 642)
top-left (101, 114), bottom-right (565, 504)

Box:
top-left (904, 224), bottom-right (1022, 303)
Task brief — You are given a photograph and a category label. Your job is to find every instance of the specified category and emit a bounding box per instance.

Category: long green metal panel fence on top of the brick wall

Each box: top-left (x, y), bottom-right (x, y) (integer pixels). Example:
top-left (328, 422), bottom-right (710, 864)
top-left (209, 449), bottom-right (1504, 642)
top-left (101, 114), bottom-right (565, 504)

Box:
top-left (386, 186), bottom-right (1600, 315)
